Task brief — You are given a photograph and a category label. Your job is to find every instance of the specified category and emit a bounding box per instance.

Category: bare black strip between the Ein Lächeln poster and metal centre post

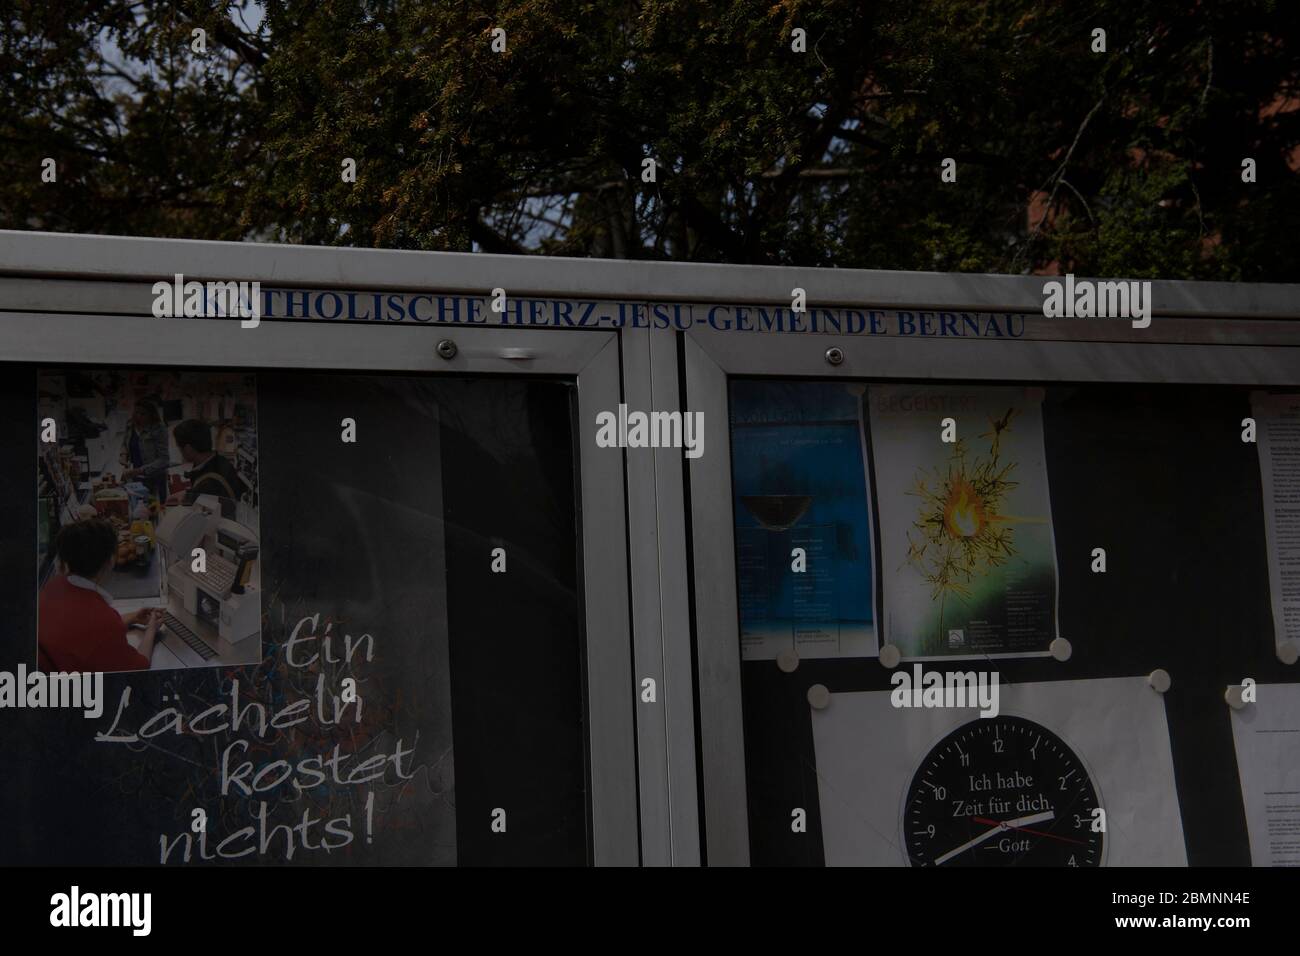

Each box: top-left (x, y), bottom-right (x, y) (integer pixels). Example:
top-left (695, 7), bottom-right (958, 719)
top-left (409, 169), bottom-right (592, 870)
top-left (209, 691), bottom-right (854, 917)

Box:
top-left (442, 381), bottom-right (588, 865)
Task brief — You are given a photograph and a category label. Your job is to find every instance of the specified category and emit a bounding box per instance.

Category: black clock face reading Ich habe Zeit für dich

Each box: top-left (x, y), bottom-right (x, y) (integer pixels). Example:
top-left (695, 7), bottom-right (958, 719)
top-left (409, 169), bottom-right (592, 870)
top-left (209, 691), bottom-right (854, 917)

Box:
top-left (902, 715), bottom-right (1105, 866)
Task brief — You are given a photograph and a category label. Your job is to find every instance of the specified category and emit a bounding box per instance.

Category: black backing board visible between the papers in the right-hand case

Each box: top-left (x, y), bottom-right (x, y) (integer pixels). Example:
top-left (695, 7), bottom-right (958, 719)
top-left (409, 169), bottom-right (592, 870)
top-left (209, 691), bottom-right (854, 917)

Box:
top-left (741, 385), bottom-right (1300, 866)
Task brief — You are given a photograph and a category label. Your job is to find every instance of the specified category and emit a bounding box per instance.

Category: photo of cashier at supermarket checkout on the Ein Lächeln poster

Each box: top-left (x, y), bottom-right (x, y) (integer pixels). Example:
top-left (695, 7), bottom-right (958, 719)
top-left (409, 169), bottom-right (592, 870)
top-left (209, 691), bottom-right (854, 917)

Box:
top-left (36, 369), bottom-right (261, 672)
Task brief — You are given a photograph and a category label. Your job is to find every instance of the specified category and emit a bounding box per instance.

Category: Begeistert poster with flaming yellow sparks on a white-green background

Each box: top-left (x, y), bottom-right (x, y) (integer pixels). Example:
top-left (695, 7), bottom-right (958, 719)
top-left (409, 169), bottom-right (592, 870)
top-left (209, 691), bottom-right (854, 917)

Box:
top-left (867, 385), bottom-right (1057, 659)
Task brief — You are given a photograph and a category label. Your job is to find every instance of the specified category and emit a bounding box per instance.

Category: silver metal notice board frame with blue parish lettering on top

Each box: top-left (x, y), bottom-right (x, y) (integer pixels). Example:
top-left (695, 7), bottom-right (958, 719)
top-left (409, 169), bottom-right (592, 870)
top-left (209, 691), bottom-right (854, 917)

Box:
top-left (0, 232), bottom-right (1300, 865)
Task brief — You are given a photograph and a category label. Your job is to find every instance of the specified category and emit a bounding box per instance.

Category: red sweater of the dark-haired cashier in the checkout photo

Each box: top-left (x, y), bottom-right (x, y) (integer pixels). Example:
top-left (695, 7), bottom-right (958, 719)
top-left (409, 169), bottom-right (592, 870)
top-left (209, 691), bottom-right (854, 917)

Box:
top-left (36, 575), bottom-right (150, 672)
